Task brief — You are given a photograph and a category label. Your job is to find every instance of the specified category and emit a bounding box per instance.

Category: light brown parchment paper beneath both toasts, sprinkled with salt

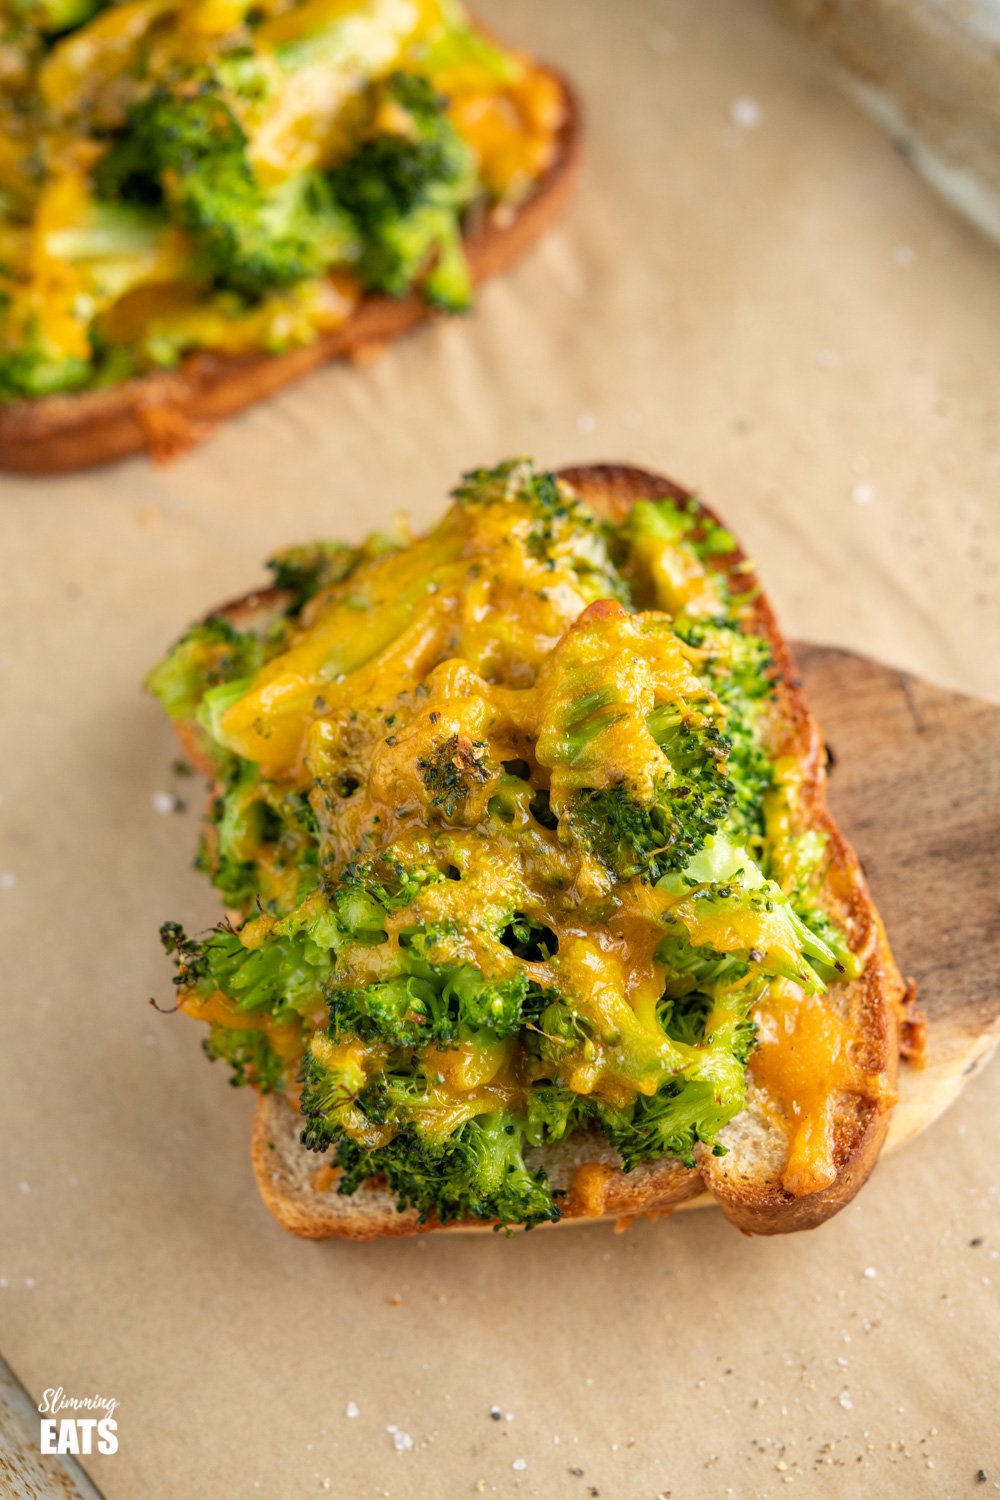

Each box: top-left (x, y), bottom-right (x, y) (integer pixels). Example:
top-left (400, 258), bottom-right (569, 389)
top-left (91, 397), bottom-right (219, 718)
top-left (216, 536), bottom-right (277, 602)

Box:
top-left (0, 0), bottom-right (1000, 1500)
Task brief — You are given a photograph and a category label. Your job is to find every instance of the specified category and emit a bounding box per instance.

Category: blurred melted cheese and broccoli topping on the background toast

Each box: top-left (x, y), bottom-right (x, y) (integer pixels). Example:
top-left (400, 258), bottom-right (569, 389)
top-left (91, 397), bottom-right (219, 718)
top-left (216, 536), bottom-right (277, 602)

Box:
top-left (0, 0), bottom-right (565, 401)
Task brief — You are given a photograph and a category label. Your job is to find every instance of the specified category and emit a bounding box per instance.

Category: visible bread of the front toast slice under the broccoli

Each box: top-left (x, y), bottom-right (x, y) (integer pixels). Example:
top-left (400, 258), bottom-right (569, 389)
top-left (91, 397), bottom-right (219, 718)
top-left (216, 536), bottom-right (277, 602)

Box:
top-left (170, 465), bottom-right (937, 1239)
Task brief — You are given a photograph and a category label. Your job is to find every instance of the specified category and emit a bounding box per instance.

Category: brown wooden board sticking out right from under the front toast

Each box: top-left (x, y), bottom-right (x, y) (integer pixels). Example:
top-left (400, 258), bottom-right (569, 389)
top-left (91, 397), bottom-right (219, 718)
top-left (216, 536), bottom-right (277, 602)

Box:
top-left (795, 645), bottom-right (1000, 1149)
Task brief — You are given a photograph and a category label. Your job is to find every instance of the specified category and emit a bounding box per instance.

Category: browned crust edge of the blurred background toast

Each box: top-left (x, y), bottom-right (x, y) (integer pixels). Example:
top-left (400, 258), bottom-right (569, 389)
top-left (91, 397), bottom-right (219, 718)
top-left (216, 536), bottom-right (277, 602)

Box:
top-left (0, 69), bottom-right (580, 474)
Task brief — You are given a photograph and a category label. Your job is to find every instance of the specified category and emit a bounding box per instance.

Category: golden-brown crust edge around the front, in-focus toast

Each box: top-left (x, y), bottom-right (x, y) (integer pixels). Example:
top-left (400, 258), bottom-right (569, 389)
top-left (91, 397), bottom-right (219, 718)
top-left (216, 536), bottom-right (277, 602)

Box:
top-left (178, 465), bottom-right (904, 1239)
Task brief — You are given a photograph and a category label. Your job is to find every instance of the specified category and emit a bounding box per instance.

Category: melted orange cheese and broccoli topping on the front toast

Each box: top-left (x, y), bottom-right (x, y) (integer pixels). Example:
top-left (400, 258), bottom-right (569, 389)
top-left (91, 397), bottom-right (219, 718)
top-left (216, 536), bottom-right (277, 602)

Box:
top-left (150, 461), bottom-right (889, 1224)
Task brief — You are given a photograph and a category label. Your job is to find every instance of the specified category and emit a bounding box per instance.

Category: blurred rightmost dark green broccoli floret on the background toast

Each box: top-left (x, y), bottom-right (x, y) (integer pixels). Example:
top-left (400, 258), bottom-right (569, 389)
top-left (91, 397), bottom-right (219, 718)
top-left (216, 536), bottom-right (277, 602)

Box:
top-left (328, 74), bottom-right (477, 312)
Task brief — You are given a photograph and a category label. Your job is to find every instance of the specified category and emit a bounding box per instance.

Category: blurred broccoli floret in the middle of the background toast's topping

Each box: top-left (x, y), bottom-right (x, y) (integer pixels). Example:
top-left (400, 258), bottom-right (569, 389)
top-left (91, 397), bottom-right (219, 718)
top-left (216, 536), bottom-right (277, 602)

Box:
top-left (94, 84), bottom-right (355, 297)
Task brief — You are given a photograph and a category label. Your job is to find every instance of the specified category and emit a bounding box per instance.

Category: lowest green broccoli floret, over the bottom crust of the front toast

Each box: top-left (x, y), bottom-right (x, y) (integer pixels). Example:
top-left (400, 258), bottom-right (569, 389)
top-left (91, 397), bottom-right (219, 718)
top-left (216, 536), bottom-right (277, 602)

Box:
top-left (325, 1101), bottom-right (559, 1229)
